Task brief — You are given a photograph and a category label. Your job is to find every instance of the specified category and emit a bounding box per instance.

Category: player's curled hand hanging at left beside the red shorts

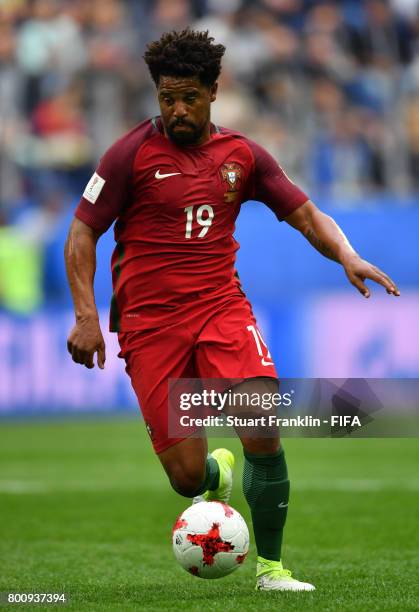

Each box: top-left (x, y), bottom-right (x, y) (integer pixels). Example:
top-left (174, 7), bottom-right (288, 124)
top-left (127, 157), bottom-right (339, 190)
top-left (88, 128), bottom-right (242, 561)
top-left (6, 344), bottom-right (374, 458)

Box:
top-left (67, 317), bottom-right (106, 370)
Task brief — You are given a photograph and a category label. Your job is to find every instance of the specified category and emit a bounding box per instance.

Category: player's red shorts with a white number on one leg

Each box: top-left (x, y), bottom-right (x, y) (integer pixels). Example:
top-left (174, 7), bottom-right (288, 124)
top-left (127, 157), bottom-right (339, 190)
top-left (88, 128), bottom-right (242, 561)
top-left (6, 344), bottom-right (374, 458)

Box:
top-left (118, 295), bottom-right (277, 453)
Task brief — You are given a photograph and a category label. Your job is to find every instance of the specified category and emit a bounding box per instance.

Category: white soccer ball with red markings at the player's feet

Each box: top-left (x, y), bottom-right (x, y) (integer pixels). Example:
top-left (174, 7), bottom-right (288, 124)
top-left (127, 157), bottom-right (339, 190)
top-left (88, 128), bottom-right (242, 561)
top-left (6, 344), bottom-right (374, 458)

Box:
top-left (172, 501), bottom-right (249, 578)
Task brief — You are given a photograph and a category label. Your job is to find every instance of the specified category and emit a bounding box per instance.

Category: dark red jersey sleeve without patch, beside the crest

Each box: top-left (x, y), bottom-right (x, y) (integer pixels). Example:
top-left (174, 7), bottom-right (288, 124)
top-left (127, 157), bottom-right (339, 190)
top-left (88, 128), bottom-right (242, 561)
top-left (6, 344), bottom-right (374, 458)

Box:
top-left (248, 141), bottom-right (309, 221)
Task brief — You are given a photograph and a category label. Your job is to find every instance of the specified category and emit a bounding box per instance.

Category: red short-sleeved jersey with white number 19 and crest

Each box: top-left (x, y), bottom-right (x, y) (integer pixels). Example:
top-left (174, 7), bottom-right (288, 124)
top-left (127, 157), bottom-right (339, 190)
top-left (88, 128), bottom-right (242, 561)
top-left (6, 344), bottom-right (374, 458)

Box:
top-left (75, 118), bottom-right (308, 331)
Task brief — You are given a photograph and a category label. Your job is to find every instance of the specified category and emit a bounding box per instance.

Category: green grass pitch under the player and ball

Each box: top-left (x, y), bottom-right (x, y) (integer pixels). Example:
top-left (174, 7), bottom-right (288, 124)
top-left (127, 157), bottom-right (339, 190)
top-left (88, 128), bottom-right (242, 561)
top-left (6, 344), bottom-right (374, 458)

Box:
top-left (0, 418), bottom-right (419, 612)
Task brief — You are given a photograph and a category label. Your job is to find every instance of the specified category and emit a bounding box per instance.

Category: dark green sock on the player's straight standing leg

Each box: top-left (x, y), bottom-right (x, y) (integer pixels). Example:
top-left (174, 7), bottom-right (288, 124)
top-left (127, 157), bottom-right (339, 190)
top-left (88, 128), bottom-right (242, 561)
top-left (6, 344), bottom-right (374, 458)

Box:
top-left (243, 448), bottom-right (290, 561)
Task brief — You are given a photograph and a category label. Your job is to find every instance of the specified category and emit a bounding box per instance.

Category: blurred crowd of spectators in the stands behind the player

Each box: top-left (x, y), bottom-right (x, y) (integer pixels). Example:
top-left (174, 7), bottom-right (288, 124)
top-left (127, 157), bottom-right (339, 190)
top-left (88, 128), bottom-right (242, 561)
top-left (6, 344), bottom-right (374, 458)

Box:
top-left (0, 0), bottom-right (419, 310)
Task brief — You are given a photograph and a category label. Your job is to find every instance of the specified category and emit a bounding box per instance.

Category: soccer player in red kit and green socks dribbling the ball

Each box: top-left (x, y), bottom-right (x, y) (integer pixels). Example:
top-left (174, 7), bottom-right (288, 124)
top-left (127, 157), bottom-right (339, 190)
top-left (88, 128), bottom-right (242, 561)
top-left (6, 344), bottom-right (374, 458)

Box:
top-left (65, 29), bottom-right (399, 591)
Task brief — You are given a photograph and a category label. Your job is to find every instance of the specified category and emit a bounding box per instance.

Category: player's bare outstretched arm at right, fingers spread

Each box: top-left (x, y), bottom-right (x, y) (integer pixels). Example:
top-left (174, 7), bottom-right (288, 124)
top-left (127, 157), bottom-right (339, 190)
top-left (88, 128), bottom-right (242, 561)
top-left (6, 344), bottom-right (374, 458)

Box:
top-left (284, 200), bottom-right (400, 298)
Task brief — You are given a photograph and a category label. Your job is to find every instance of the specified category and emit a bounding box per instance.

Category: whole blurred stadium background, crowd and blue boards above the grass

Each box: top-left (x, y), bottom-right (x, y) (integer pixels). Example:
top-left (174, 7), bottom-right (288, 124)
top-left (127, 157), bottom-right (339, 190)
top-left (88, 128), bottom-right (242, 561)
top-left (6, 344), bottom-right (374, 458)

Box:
top-left (0, 0), bottom-right (419, 414)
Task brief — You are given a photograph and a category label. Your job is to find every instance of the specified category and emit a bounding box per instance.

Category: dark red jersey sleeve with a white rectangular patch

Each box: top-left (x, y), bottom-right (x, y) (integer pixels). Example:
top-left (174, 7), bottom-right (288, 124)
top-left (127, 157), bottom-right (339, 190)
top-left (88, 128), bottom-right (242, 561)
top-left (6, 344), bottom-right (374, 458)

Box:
top-left (75, 141), bottom-right (132, 233)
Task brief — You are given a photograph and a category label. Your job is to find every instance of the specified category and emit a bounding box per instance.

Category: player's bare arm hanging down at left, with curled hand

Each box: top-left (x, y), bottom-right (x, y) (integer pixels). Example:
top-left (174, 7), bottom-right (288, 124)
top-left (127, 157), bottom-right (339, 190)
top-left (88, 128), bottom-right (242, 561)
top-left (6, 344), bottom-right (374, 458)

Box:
top-left (64, 217), bottom-right (106, 369)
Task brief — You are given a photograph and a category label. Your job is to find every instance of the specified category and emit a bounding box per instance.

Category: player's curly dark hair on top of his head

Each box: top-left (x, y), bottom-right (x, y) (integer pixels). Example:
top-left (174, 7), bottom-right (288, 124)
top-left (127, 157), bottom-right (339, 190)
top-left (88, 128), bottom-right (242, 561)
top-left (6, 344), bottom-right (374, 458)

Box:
top-left (144, 28), bottom-right (225, 87)
